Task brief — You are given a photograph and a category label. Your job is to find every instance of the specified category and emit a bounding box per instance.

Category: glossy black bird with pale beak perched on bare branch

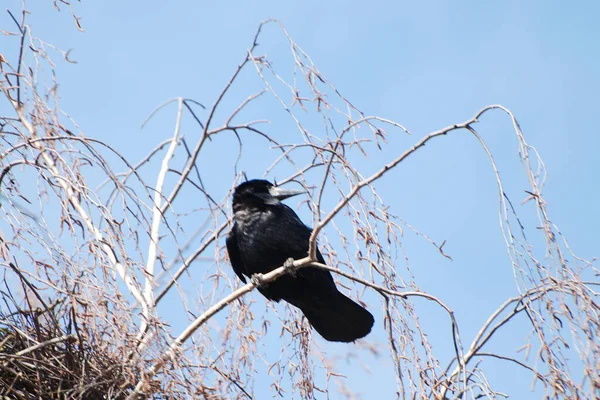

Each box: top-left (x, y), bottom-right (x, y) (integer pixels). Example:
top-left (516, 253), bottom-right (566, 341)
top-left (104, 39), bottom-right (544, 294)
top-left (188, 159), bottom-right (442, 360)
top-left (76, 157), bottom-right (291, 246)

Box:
top-left (227, 179), bottom-right (374, 342)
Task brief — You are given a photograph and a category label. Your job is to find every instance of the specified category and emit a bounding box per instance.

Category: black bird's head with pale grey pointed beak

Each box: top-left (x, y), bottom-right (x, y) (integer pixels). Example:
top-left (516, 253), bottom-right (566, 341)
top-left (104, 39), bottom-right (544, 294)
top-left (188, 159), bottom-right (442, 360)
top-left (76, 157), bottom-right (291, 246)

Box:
top-left (233, 179), bottom-right (305, 212)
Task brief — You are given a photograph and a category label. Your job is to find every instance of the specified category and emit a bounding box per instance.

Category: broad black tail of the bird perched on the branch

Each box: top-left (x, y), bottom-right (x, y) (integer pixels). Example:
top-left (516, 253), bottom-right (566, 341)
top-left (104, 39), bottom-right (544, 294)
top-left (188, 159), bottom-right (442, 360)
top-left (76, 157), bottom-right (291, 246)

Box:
top-left (300, 292), bottom-right (374, 342)
